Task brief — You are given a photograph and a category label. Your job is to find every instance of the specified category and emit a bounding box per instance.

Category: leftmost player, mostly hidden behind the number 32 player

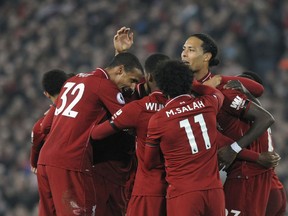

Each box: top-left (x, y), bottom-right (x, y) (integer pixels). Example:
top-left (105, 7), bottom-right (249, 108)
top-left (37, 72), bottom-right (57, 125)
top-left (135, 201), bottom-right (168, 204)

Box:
top-left (30, 69), bottom-right (68, 174)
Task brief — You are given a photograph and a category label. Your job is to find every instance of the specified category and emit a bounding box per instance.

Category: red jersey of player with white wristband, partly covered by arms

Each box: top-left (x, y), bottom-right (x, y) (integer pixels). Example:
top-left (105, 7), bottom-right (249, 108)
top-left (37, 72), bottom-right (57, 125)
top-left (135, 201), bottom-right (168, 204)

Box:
top-left (217, 89), bottom-right (273, 178)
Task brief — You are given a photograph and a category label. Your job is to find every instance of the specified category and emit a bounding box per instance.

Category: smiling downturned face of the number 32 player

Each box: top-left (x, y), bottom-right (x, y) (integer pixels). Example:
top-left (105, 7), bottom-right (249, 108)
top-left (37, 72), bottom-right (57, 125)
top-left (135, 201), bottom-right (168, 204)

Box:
top-left (116, 68), bottom-right (143, 90)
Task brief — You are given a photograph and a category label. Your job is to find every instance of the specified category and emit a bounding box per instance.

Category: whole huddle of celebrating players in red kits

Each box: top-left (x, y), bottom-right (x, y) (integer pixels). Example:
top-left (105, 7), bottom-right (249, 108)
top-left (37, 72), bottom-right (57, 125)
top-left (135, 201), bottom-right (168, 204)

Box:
top-left (30, 27), bottom-right (286, 216)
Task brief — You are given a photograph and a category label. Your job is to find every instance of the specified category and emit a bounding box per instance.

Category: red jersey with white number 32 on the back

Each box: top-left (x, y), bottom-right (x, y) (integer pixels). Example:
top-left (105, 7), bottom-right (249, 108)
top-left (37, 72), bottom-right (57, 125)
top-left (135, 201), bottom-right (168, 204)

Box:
top-left (38, 68), bottom-right (125, 171)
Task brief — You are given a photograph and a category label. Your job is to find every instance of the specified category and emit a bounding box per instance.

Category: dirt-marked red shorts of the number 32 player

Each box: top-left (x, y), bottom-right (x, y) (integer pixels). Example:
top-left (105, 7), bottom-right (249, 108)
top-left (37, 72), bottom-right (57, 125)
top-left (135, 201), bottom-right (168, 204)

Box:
top-left (37, 164), bottom-right (96, 216)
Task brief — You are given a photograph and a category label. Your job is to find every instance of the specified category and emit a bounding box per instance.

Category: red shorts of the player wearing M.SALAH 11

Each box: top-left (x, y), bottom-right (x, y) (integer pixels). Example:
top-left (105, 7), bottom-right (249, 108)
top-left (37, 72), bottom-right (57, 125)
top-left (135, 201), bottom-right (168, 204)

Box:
top-left (167, 189), bottom-right (225, 216)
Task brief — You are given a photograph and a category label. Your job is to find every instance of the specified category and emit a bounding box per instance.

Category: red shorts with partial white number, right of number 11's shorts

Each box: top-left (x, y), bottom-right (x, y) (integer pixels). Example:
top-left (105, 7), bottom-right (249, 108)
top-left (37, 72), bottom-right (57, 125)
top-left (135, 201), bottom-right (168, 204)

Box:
top-left (224, 171), bottom-right (272, 216)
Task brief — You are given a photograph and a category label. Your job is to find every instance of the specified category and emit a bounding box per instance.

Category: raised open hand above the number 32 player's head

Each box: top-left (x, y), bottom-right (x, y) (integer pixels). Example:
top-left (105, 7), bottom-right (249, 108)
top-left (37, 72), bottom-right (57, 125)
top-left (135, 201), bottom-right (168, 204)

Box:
top-left (113, 26), bottom-right (134, 55)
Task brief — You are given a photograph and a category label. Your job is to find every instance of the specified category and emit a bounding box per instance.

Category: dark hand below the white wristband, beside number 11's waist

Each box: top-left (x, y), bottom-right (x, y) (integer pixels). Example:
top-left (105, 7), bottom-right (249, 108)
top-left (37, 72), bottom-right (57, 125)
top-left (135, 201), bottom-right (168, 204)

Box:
top-left (217, 146), bottom-right (237, 171)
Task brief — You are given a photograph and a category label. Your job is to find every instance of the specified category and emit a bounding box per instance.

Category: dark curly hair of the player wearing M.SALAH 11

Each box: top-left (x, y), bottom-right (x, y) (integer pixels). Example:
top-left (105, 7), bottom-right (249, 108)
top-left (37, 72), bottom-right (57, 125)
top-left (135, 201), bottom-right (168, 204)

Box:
top-left (154, 60), bottom-right (194, 98)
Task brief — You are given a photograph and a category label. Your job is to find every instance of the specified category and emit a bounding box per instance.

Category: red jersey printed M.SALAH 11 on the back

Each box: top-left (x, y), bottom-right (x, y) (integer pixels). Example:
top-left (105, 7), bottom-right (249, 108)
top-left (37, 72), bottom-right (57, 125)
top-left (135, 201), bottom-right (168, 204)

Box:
top-left (146, 95), bottom-right (223, 198)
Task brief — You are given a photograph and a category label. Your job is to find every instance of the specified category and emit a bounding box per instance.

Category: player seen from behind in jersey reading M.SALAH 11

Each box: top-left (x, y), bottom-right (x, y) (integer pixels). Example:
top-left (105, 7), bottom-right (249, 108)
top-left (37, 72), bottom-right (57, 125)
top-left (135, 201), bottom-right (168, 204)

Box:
top-left (144, 61), bottom-right (225, 216)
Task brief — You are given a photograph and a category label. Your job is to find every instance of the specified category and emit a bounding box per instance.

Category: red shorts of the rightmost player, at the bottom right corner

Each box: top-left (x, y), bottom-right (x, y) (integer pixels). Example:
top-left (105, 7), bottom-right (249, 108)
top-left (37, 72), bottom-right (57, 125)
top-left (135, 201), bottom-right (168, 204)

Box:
top-left (266, 188), bottom-right (286, 216)
